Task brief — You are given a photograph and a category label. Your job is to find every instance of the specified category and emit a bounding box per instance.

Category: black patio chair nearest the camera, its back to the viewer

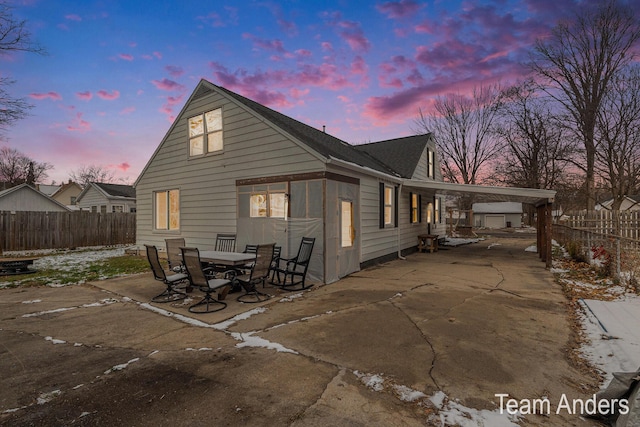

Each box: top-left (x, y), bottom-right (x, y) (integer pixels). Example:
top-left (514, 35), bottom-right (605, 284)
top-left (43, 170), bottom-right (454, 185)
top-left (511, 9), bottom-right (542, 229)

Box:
top-left (181, 248), bottom-right (236, 313)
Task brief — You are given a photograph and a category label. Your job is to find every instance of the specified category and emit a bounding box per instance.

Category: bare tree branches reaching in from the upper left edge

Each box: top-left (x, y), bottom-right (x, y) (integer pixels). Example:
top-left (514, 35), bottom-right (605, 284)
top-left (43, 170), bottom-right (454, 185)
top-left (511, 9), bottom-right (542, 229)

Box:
top-left (0, 1), bottom-right (46, 129)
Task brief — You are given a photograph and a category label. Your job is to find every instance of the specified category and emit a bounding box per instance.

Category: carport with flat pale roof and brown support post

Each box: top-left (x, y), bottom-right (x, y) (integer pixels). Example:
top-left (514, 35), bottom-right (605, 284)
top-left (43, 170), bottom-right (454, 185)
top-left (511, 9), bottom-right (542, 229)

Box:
top-left (401, 179), bottom-right (556, 268)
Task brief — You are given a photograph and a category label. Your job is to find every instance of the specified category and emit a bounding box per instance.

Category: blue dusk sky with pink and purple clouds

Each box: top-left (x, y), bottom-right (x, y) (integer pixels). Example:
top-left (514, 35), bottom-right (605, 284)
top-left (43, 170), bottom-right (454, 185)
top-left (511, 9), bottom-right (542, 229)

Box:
top-left (0, 0), bottom-right (640, 183)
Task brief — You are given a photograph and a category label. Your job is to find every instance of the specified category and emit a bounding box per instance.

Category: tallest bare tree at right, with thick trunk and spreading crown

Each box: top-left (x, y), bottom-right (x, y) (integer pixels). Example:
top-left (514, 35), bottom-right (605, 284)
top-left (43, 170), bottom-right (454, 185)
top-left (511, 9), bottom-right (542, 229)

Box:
top-left (532, 0), bottom-right (640, 209)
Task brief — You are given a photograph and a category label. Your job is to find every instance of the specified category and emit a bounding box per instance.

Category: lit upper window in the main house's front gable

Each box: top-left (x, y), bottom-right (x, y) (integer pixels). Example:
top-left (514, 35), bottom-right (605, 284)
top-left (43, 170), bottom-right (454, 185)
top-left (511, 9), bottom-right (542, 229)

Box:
top-left (189, 108), bottom-right (224, 157)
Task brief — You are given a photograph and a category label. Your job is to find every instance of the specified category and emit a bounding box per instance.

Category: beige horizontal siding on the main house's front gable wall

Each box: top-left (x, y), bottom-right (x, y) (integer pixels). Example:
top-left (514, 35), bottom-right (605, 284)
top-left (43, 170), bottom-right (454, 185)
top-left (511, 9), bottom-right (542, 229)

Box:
top-left (136, 93), bottom-right (324, 249)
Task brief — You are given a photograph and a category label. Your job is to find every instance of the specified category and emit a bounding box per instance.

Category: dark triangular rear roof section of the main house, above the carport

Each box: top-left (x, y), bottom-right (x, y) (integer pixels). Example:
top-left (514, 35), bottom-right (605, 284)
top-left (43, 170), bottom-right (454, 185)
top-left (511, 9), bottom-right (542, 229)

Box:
top-left (354, 134), bottom-right (430, 178)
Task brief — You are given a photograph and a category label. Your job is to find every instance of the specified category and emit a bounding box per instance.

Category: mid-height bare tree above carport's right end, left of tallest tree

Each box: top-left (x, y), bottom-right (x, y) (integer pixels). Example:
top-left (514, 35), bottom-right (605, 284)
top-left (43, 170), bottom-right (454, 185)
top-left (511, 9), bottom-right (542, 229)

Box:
top-left (494, 80), bottom-right (574, 189)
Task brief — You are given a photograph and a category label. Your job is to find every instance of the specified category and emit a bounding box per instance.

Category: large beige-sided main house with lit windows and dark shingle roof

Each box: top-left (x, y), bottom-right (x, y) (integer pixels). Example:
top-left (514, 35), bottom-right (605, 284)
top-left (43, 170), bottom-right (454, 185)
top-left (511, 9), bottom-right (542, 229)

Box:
top-left (135, 80), bottom-right (445, 283)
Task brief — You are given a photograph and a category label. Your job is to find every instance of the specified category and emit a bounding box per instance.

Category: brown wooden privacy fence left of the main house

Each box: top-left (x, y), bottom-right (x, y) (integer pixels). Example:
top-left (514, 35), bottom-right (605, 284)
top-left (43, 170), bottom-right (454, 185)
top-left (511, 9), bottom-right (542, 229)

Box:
top-left (0, 211), bottom-right (136, 253)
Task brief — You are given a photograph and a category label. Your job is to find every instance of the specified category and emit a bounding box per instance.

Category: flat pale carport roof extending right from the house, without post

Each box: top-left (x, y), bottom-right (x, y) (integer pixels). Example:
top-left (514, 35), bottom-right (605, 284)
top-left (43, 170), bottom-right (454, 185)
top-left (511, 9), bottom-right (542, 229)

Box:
top-left (402, 179), bottom-right (556, 205)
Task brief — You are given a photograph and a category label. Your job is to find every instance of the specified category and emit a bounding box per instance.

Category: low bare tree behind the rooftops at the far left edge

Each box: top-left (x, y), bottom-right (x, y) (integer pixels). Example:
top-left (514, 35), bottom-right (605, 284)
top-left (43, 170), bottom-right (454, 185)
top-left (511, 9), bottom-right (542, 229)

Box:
top-left (0, 147), bottom-right (53, 187)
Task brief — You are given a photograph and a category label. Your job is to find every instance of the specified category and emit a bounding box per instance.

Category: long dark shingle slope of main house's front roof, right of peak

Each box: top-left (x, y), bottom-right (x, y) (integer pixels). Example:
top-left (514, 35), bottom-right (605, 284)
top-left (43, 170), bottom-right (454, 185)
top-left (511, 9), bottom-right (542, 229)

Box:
top-left (215, 82), bottom-right (398, 175)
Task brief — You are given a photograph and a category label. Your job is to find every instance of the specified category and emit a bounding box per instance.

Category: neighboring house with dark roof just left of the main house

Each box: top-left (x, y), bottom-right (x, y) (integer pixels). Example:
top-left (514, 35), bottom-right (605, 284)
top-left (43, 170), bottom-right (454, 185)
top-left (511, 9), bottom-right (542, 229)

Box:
top-left (76, 182), bottom-right (136, 213)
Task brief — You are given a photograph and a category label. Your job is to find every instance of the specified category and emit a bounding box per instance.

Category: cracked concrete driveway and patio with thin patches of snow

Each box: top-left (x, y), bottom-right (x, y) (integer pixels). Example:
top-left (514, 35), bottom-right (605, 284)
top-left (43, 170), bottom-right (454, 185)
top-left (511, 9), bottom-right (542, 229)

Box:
top-left (0, 235), bottom-right (599, 426)
